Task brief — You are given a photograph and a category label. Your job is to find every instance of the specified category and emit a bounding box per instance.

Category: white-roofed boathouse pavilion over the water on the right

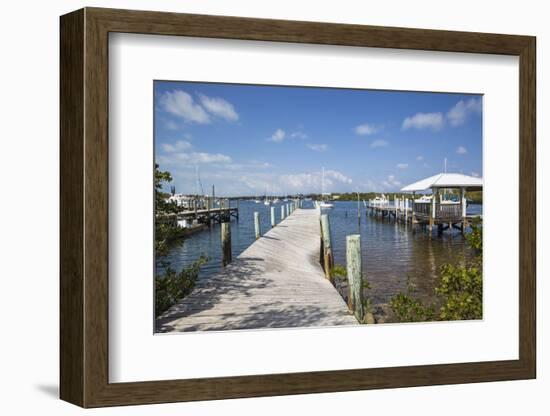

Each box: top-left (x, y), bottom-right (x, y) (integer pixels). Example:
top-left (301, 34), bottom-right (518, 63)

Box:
top-left (401, 173), bottom-right (483, 230)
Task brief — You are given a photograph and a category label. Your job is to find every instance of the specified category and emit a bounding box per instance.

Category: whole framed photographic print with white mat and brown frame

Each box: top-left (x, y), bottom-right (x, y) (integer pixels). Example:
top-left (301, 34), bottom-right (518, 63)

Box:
top-left (60, 8), bottom-right (536, 407)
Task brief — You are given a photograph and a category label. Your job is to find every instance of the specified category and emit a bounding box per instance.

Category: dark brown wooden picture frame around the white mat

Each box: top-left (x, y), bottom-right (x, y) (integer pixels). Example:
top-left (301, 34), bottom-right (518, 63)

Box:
top-left (60, 8), bottom-right (536, 407)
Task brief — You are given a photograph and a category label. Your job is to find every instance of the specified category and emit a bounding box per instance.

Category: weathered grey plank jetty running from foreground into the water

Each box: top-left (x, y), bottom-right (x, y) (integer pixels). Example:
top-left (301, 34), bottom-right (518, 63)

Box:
top-left (156, 208), bottom-right (358, 332)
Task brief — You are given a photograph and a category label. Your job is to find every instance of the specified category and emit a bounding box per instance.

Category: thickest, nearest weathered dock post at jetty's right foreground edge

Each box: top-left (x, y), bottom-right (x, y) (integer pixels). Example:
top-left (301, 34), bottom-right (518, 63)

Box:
top-left (346, 234), bottom-right (365, 322)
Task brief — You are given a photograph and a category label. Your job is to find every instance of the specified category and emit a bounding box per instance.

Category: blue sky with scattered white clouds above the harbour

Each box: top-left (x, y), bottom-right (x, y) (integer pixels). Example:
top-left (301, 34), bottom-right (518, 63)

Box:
top-left (154, 81), bottom-right (482, 196)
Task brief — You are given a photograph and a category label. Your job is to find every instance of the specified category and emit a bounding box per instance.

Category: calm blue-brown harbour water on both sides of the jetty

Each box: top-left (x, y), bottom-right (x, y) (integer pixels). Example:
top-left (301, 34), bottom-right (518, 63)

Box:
top-left (157, 201), bottom-right (481, 304)
